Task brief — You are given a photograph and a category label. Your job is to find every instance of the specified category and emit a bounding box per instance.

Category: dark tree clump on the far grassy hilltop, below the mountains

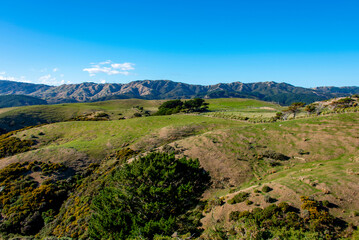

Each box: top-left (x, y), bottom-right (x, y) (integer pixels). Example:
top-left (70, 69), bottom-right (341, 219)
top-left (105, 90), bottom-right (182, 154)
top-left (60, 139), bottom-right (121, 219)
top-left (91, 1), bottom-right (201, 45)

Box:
top-left (155, 98), bottom-right (209, 115)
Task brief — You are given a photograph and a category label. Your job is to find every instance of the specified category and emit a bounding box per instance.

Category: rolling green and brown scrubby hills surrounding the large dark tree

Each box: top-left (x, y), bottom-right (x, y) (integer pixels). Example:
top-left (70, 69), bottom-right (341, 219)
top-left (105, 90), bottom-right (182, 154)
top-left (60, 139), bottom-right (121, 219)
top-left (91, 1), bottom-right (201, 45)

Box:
top-left (0, 98), bottom-right (359, 239)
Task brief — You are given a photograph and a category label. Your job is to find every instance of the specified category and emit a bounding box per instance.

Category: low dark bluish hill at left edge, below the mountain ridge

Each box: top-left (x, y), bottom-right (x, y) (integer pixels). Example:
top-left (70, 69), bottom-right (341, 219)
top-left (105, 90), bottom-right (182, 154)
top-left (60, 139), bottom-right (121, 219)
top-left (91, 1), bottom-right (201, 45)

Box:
top-left (0, 95), bottom-right (47, 108)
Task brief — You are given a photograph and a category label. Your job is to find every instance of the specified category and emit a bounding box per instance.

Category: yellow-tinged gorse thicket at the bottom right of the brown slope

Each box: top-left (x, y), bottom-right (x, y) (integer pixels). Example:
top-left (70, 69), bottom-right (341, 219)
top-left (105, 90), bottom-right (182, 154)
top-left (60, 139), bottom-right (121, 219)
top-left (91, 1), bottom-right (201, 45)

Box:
top-left (227, 197), bottom-right (346, 239)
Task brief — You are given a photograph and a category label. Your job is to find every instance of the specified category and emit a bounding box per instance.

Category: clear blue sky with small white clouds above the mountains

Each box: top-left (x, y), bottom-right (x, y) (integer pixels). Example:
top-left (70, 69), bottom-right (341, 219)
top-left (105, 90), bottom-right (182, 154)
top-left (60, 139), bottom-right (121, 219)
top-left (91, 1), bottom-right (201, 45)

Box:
top-left (0, 0), bottom-right (359, 87)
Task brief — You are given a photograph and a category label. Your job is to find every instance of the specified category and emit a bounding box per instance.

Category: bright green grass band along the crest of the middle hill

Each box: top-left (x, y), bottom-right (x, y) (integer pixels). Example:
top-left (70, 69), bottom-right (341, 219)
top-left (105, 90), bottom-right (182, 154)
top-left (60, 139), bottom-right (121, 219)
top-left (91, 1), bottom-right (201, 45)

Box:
top-left (18, 115), bottom-right (249, 157)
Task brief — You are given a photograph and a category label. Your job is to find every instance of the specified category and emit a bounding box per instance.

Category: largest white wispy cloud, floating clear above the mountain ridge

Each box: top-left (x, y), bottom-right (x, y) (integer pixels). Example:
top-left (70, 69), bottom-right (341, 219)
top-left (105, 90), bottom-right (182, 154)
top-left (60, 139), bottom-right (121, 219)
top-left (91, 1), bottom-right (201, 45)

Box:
top-left (82, 60), bottom-right (135, 77)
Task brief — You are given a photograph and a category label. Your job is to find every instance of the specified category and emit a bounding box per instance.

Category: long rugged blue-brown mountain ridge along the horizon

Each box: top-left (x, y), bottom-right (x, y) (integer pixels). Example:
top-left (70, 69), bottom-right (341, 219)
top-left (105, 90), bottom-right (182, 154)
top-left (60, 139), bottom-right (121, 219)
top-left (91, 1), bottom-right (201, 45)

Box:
top-left (0, 80), bottom-right (359, 105)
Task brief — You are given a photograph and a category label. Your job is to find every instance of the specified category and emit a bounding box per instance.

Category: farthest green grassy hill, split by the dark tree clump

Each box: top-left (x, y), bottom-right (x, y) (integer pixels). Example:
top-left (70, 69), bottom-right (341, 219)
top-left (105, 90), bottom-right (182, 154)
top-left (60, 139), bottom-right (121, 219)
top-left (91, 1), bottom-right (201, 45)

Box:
top-left (0, 99), bottom-right (279, 131)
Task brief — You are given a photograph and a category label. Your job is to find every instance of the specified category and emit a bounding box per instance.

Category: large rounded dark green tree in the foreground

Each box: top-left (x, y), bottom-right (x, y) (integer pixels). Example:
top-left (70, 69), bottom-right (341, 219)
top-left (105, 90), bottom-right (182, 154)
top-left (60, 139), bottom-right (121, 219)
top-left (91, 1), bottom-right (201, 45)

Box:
top-left (89, 153), bottom-right (210, 239)
